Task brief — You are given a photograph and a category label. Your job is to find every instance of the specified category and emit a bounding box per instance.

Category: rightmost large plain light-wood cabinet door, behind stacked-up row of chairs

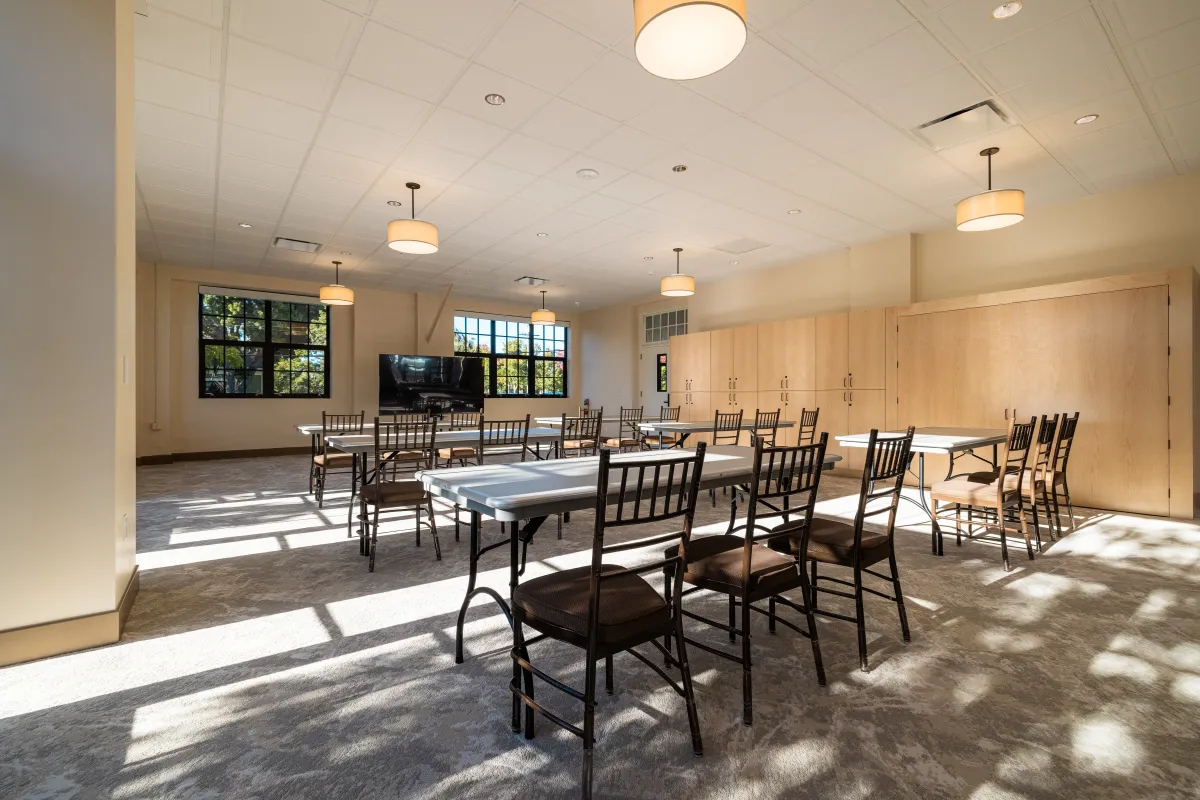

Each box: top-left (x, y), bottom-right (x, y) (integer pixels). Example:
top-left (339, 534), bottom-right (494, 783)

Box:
top-left (1006, 285), bottom-right (1171, 515)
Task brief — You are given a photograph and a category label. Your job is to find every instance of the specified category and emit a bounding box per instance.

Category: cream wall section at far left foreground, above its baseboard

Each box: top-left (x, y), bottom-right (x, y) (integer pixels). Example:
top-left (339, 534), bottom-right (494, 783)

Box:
top-left (0, 0), bottom-right (136, 638)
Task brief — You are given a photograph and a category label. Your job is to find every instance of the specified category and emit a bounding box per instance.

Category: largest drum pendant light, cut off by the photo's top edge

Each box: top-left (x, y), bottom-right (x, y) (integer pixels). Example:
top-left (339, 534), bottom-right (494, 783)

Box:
top-left (634, 0), bottom-right (746, 80)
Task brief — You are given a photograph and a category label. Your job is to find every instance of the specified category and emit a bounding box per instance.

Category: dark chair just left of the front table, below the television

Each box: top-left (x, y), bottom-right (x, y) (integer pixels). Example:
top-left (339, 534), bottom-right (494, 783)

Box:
top-left (359, 417), bottom-right (442, 572)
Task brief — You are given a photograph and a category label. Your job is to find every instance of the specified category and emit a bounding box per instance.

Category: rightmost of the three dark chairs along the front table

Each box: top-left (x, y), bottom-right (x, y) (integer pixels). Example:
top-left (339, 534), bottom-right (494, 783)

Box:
top-left (772, 427), bottom-right (913, 672)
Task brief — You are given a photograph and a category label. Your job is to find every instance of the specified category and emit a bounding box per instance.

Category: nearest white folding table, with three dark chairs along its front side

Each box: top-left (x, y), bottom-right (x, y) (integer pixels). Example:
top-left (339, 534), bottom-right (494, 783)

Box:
top-left (418, 446), bottom-right (841, 663)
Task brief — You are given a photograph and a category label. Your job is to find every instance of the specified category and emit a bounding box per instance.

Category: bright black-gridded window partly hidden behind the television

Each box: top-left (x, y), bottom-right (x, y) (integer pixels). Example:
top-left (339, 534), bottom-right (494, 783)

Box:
top-left (454, 315), bottom-right (569, 397)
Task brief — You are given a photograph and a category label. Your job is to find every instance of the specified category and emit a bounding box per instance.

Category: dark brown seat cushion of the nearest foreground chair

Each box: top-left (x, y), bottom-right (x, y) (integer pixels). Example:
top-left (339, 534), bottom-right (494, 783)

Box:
top-left (512, 564), bottom-right (671, 644)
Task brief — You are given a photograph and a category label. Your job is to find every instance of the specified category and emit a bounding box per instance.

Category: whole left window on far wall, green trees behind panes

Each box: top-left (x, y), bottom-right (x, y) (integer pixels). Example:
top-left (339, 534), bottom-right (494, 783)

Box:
top-left (199, 293), bottom-right (330, 397)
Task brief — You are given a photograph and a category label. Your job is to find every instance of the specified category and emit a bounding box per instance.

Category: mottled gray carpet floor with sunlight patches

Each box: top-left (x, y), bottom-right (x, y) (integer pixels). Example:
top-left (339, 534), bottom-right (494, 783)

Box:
top-left (0, 457), bottom-right (1200, 800)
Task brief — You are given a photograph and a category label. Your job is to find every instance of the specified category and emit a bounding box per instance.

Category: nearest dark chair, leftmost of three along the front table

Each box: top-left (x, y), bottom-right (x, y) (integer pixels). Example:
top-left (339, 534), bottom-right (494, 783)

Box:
top-left (510, 444), bottom-right (704, 800)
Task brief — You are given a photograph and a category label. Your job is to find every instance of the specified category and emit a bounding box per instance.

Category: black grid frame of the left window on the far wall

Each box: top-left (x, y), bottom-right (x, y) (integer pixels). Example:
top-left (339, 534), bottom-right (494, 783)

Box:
top-left (196, 291), bottom-right (334, 399)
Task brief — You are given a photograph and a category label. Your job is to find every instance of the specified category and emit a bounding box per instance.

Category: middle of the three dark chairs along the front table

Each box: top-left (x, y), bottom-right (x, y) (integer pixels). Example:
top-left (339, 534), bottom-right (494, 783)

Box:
top-left (664, 433), bottom-right (828, 724)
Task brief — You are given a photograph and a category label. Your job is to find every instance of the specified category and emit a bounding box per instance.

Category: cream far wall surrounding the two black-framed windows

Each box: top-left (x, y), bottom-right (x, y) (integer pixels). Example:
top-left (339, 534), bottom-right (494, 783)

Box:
top-left (137, 263), bottom-right (582, 457)
